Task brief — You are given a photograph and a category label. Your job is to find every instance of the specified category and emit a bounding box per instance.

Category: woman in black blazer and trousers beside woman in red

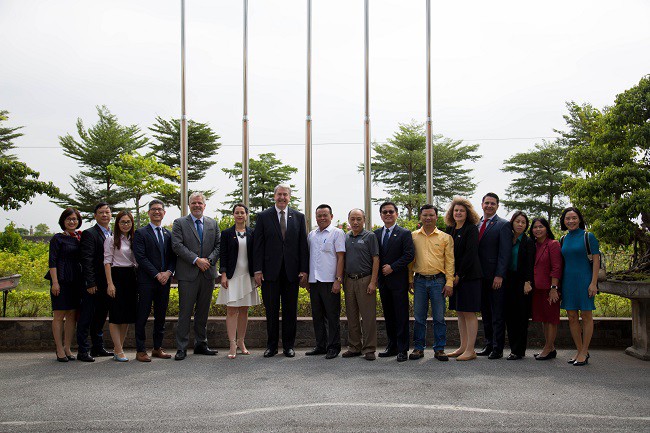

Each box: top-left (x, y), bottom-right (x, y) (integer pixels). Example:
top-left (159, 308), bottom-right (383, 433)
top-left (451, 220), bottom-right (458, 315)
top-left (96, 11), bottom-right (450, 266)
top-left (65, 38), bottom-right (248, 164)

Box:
top-left (504, 211), bottom-right (535, 361)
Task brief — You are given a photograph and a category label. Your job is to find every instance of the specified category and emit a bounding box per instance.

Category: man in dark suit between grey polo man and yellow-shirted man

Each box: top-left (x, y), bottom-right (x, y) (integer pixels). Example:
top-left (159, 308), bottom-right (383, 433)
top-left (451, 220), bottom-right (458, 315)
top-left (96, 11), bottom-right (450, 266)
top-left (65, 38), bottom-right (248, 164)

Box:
top-left (375, 201), bottom-right (415, 362)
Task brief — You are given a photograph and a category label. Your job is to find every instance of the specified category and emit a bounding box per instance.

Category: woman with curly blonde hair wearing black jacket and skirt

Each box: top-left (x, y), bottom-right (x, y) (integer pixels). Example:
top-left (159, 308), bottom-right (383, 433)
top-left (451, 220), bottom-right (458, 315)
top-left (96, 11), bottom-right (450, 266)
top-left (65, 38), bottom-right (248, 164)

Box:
top-left (445, 197), bottom-right (482, 361)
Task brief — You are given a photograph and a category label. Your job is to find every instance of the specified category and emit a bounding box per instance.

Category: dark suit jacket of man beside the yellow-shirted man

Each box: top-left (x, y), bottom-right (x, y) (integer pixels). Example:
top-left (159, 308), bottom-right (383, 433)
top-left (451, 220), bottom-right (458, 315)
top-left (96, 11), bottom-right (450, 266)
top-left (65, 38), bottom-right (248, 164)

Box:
top-left (375, 225), bottom-right (415, 290)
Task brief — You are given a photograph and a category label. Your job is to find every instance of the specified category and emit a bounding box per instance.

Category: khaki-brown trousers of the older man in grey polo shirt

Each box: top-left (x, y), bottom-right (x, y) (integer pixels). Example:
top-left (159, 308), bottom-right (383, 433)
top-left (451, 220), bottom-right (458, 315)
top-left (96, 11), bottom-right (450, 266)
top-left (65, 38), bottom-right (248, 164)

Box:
top-left (343, 275), bottom-right (377, 354)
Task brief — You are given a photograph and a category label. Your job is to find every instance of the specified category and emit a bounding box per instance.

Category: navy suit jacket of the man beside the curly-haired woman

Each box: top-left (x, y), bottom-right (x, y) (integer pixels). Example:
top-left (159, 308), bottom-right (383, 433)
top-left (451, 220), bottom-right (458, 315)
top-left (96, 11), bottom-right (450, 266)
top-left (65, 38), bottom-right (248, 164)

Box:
top-left (477, 215), bottom-right (512, 280)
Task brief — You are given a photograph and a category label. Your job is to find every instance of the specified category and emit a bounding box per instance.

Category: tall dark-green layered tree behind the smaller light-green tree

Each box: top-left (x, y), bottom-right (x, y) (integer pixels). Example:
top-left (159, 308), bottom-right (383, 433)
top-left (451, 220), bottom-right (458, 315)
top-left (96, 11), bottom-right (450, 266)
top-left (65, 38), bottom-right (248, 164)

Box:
top-left (53, 106), bottom-right (148, 218)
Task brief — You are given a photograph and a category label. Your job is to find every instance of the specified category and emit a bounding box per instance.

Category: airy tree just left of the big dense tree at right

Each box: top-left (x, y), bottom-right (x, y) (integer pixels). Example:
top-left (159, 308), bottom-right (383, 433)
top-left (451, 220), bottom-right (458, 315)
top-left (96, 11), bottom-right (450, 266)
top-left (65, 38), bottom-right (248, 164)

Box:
top-left (501, 141), bottom-right (569, 221)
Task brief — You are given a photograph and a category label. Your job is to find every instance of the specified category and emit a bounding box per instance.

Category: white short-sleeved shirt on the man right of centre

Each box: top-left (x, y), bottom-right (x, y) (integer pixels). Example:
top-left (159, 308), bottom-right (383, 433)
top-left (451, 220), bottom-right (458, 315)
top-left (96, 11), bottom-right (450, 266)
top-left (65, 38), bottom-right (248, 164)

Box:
top-left (307, 224), bottom-right (345, 283)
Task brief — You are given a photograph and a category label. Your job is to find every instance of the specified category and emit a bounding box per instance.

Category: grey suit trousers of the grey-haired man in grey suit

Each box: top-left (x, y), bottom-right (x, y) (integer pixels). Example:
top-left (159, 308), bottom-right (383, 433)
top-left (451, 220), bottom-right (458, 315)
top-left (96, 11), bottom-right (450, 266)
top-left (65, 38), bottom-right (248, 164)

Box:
top-left (176, 274), bottom-right (214, 350)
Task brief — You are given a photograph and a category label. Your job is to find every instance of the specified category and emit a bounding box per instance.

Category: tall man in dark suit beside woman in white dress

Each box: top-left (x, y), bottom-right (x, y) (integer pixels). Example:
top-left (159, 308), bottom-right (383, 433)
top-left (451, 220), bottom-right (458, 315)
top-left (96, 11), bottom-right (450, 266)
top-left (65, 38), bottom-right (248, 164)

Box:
top-left (253, 184), bottom-right (309, 358)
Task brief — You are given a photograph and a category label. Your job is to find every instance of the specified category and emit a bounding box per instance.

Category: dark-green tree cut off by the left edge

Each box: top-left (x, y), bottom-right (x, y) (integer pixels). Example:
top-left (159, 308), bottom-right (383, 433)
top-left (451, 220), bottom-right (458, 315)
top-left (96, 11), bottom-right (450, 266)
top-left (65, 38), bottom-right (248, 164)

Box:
top-left (0, 111), bottom-right (59, 210)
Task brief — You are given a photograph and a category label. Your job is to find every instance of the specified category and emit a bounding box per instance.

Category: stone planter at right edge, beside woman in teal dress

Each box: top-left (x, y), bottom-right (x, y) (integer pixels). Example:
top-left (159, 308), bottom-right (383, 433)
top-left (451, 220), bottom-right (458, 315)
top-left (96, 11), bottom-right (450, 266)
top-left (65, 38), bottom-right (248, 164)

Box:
top-left (598, 280), bottom-right (650, 361)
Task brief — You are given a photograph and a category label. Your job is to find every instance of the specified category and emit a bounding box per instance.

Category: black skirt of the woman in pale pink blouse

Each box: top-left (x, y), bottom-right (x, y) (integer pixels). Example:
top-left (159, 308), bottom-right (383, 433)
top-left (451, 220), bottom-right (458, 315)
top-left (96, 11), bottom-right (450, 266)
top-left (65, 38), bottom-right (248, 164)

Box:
top-left (108, 267), bottom-right (138, 325)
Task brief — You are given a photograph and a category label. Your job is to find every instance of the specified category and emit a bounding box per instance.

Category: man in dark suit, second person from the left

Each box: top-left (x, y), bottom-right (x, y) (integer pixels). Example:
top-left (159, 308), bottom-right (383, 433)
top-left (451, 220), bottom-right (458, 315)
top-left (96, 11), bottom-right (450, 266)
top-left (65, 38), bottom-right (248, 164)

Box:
top-left (77, 202), bottom-right (113, 362)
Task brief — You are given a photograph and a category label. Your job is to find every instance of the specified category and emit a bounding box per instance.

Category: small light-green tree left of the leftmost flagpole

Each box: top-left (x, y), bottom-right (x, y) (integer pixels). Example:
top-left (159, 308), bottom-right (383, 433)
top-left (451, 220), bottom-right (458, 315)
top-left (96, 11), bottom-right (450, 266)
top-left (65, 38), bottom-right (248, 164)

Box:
top-left (106, 152), bottom-right (178, 227)
